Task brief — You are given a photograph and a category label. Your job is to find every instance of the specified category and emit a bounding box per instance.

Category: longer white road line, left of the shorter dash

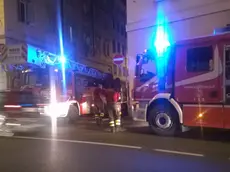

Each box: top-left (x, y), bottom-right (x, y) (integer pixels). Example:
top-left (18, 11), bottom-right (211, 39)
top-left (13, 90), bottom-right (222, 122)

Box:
top-left (12, 136), bottom-right (142, 149)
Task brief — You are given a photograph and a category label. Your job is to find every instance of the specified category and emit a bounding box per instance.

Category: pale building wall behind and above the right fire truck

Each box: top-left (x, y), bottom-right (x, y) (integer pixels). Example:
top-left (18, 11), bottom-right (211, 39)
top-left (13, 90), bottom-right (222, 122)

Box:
top-left (126, 0), bottom-right (230, 97)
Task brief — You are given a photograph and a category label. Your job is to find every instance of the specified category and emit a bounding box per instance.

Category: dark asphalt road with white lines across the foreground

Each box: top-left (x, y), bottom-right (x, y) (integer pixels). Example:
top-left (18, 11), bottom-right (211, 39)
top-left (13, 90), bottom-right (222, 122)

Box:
top-left (0, 117), bottom-right (230, 172)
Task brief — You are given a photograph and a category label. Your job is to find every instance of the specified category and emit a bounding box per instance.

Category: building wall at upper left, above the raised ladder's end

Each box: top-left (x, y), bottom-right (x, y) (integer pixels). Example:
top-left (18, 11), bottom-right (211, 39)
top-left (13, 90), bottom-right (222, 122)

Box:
top-left (4, 0), bottom-right (59, 53)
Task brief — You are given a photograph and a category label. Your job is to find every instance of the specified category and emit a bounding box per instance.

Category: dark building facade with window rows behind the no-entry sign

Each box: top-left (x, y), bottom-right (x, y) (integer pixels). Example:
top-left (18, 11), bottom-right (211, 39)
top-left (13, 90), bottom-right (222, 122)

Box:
top-left (63, 0), bottom-right (127, 97)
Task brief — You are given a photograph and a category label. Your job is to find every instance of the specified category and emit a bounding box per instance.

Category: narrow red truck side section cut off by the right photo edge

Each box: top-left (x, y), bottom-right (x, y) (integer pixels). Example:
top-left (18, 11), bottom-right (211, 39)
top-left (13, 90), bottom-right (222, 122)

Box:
top-left (223, 45), bottom-right (230, 129)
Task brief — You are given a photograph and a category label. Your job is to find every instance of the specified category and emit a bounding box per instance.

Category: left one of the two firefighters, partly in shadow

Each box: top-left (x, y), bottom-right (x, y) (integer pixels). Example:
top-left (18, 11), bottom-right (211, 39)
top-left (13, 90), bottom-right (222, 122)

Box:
top-left (94, 84), bottom-right (106, 125)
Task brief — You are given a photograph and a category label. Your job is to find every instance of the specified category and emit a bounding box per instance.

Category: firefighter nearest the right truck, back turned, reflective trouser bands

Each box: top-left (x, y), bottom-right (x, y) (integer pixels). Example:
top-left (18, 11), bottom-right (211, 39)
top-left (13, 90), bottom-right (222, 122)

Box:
top-left (106, 84), bottom-right (121, 133)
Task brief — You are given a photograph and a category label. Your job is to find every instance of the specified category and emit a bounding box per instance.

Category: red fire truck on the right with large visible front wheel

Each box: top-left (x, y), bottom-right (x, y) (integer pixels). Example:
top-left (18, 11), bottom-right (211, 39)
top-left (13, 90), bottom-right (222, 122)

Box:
top-left (133, 33), bottom-right (230, 135)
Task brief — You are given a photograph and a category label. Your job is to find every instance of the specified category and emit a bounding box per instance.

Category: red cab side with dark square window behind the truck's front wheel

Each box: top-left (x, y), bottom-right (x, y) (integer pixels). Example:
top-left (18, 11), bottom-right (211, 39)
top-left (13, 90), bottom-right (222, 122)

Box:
top-left (179, 45), bottom-right (223, 128)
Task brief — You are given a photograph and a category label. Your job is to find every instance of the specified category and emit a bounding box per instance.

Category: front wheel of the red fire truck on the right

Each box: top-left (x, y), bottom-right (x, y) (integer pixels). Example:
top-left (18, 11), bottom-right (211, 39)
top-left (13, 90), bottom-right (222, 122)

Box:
top-left (148, 103), bottom-right (179, 136)
